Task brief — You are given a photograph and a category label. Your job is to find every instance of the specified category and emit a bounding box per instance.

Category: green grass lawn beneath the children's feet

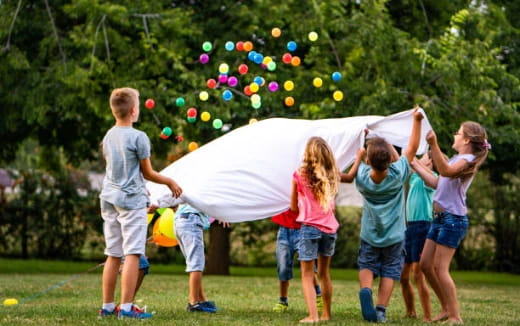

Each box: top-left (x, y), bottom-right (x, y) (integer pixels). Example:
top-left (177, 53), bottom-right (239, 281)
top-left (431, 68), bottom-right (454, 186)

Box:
top-left (0, 259), bottom-right (520, 326)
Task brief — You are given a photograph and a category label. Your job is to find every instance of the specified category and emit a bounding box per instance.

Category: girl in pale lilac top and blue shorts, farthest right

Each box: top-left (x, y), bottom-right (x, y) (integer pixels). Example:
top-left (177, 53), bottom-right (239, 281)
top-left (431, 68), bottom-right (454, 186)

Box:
top-left (417, 121), bottom-right (491, 324)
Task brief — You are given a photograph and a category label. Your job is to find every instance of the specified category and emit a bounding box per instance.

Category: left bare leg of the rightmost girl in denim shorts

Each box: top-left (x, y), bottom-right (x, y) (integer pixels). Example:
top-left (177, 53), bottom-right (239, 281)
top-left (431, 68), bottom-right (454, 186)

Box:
top-left (419, 239), bottom-right (448, 322)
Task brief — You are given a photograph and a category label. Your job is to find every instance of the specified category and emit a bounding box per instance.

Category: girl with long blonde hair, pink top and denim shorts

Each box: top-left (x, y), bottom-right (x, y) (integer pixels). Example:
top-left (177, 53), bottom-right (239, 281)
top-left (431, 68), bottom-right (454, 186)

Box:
top-left (290, 137), bottom-right (339, 323)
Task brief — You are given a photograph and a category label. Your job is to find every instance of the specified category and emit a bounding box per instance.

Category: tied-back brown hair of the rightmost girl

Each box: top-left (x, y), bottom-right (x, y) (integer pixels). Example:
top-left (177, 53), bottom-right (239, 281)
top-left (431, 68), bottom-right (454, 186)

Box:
top-left (457, 121), bottom-right (491, 179)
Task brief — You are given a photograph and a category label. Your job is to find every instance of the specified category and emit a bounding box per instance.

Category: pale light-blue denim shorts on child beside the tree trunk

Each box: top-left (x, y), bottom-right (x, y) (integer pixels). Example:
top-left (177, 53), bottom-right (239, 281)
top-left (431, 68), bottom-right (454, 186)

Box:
top-left (175, 213), bottom-right (205, 273)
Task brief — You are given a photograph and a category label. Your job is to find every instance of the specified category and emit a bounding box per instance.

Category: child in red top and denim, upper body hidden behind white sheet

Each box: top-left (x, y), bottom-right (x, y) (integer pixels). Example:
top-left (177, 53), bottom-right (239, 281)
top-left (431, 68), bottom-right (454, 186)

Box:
top-left (272, 210), bottom-right (323, 312)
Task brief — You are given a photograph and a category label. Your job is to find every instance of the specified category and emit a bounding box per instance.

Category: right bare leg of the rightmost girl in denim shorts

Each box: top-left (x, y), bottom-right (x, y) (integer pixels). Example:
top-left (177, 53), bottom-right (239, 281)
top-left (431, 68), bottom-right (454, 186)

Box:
top-left (435, 245), bottom-right (462, 324)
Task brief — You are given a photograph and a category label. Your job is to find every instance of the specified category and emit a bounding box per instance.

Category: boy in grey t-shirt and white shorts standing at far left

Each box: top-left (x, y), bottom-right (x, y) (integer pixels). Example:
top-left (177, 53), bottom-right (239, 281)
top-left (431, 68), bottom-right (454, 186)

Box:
top-left (99, 88), bottom-right (182, 319)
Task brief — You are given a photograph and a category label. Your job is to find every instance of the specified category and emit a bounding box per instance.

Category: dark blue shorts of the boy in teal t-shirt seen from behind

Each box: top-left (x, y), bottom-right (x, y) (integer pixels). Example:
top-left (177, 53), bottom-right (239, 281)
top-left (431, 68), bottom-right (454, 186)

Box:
top-left (358, 240), bottom-right (404, 281)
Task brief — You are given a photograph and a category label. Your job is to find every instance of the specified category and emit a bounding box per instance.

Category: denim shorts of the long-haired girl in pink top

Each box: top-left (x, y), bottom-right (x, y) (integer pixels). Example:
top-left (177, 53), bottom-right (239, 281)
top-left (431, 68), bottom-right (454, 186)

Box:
top-left (298, 225), bottom-right (337, 261)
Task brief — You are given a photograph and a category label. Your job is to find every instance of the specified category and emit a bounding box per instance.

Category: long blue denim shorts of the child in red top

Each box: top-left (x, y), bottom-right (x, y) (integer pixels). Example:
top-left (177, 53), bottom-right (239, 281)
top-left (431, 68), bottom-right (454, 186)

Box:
top-left (276, 226), bottom-right (300, 282)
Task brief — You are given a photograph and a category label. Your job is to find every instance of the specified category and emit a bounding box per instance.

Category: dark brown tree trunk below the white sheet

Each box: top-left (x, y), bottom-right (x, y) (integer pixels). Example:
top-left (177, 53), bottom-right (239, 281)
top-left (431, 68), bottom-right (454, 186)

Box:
top-left (204, 222), bottom-right (231, 275)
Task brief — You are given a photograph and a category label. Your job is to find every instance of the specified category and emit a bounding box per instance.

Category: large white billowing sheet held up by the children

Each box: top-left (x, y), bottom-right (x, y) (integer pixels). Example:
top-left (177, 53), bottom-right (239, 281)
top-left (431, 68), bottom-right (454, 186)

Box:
top-left (147, 110), bottom-right (431, 223)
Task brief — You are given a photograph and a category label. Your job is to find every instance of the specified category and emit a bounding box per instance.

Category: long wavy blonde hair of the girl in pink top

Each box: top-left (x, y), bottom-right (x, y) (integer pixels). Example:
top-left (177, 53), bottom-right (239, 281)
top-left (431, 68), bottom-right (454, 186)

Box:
top-left (300, 137), bottom-right (339, 210)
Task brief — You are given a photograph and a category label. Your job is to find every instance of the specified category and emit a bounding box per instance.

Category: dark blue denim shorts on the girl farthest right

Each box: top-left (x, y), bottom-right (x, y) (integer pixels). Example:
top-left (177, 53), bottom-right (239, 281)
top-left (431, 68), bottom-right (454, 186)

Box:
top-left (426, 212), bottom-right (469, 249)
